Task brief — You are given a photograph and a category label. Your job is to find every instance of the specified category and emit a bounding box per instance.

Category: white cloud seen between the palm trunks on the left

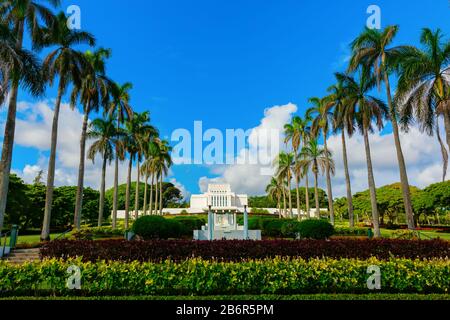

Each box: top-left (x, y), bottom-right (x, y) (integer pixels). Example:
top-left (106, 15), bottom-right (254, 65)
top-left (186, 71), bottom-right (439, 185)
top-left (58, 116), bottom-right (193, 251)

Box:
top-left (2, 101), bottom-right (158, 189)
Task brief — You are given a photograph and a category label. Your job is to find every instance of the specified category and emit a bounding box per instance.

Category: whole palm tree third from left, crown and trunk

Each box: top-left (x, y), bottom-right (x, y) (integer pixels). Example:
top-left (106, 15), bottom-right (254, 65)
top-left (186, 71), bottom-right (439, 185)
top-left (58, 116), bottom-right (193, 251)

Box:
top-left (71, 48), bottom-right (111, 229)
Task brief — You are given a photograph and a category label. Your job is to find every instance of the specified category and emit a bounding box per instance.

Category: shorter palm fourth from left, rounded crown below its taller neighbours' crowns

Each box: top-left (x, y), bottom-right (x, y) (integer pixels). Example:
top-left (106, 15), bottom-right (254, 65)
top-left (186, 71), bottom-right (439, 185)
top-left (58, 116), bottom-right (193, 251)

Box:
top-left (87, 116), bottom-right (123, 227)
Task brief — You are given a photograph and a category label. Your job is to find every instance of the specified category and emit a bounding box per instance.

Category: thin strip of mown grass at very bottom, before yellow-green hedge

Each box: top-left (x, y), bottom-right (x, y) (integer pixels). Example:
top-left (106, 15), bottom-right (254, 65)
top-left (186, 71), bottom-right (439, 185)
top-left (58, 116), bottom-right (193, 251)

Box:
top-left (0, 294), bottom-right (450, 301)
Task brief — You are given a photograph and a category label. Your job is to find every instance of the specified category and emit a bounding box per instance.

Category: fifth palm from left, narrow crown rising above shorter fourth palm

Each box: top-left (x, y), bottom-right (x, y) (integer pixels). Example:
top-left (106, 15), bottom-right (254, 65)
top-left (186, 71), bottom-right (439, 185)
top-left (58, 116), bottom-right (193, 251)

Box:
top-left (108, 82), bottom-right (133, 229)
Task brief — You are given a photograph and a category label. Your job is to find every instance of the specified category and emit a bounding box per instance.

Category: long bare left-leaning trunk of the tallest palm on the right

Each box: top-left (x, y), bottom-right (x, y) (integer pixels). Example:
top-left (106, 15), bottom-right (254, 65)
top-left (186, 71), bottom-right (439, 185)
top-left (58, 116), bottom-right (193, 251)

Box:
top-left (384, 72), bottom-right (414, 230)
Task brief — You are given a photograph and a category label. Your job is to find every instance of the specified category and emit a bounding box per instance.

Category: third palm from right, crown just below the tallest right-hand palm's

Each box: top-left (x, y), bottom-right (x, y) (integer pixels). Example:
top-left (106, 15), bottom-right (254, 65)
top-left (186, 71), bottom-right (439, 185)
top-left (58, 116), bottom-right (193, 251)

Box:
top-left (339, 69), bottom-right (389, 237)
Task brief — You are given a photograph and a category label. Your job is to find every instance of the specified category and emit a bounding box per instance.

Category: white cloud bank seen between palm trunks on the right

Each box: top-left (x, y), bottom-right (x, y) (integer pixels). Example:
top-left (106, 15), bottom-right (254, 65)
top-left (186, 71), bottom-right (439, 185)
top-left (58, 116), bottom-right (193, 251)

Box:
top-left (322, 123), bottom-right (442, 197)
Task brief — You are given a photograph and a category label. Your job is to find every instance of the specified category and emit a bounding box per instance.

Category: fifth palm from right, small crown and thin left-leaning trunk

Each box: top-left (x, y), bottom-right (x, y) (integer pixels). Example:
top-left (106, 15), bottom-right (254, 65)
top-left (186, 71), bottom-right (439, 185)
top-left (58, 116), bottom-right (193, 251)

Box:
top-left (306, 98), bottom-right (334, 225)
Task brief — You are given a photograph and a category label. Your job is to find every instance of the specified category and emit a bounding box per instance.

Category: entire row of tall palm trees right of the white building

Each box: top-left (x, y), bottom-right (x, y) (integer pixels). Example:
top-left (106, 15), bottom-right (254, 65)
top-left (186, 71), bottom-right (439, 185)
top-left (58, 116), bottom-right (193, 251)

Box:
top-left (267, 26), bottom-right (450, 236)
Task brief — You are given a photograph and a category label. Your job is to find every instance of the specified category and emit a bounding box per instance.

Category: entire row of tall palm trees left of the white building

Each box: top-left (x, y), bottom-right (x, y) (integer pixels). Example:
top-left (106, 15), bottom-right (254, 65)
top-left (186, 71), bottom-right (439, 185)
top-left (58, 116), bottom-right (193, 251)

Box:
top-left (0, 0), bottom-right (171, 240)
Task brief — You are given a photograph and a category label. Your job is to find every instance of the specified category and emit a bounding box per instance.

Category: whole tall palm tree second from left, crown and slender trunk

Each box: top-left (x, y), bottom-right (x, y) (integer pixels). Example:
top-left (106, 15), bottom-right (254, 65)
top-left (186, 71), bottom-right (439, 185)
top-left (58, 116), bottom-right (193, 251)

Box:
top-left (38, 13), bottom-right (95, 240)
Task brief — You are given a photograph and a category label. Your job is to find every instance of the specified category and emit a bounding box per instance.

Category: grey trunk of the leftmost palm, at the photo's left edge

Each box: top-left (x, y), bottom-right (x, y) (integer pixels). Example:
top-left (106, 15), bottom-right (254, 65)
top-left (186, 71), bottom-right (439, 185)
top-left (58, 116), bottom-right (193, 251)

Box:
top-left (0, 21), bottom-right (24, 231)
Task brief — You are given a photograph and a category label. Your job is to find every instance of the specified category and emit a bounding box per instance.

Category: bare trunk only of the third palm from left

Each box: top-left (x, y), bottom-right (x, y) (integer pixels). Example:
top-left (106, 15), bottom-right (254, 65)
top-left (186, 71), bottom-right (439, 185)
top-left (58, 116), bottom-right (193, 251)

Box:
top-left (74, 107), bottom-right (90, 230)
